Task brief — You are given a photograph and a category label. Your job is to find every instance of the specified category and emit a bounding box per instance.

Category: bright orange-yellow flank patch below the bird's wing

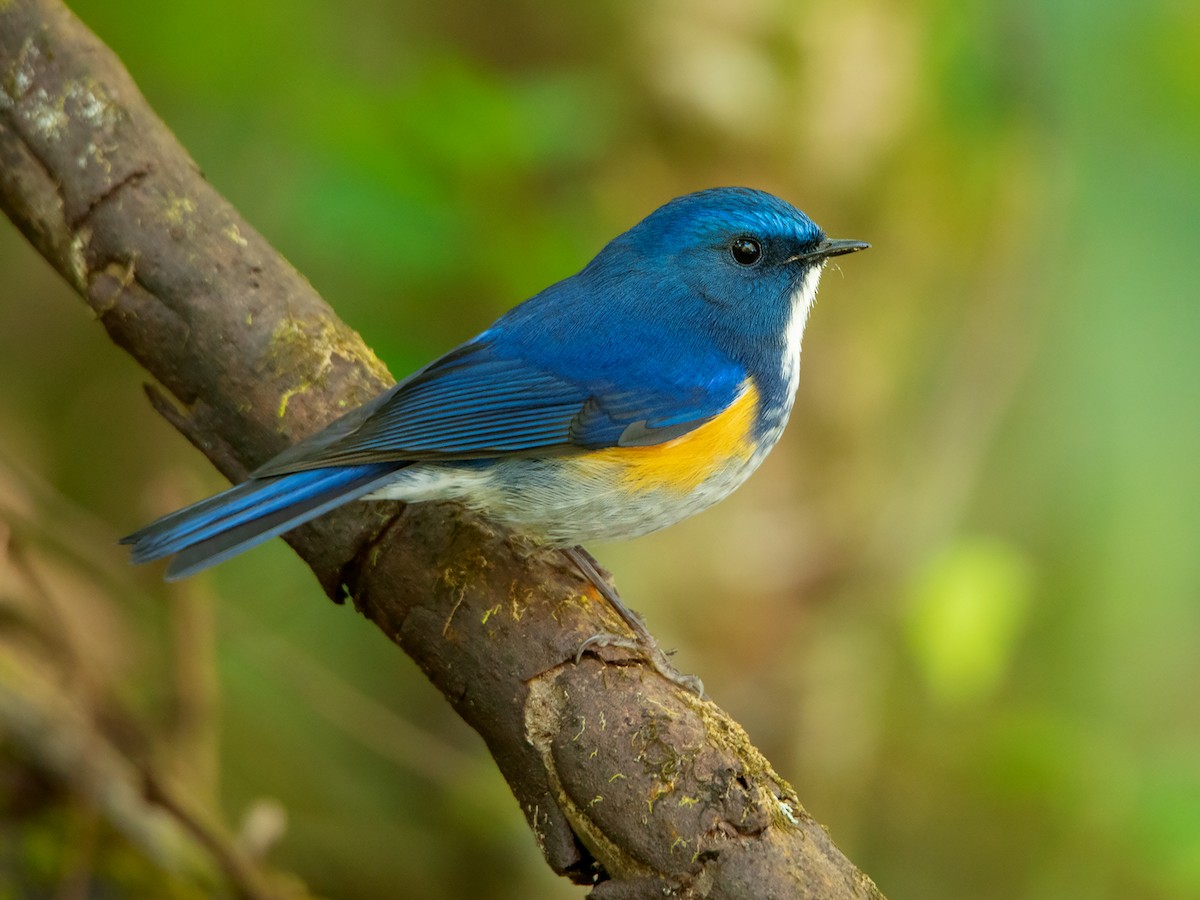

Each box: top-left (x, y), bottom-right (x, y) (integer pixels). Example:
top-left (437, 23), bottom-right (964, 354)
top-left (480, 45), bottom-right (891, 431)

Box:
top-left (578, 382), bottom-right (758, 493)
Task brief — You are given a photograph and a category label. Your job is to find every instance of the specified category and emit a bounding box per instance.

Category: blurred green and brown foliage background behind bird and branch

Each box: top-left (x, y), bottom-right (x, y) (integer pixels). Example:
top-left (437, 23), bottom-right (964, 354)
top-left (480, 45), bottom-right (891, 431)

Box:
top-left (0, 0), bottom-right (1200, 900)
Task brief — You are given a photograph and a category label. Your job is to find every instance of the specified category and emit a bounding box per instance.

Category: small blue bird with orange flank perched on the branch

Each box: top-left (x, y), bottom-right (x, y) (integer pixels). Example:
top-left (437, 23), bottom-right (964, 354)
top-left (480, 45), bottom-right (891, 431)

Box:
top-left (121, 187), bottom-right (870, 681)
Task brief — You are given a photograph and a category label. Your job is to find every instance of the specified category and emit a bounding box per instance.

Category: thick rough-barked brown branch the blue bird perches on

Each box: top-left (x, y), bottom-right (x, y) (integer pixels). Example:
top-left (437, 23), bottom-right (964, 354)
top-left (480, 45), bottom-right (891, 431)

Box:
top-left (0, 0), bottom-right (881, 900)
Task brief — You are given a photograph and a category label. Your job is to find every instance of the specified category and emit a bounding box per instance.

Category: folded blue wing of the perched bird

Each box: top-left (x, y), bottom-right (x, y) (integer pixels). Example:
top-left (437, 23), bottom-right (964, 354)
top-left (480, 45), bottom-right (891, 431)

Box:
top-left (254, 332), bottom-right (745, 475)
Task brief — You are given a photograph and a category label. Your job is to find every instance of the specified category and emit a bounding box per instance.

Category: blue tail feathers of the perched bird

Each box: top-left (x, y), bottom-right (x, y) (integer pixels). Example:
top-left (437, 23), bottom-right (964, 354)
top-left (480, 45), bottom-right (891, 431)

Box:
top-left (121, 462), bottom-right (403, 581)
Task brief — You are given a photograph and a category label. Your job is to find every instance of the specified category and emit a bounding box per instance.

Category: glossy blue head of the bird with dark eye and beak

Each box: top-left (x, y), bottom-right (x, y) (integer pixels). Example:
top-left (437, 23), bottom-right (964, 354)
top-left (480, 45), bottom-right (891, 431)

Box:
top-left (584, 187), bottom-right (868, 352)
